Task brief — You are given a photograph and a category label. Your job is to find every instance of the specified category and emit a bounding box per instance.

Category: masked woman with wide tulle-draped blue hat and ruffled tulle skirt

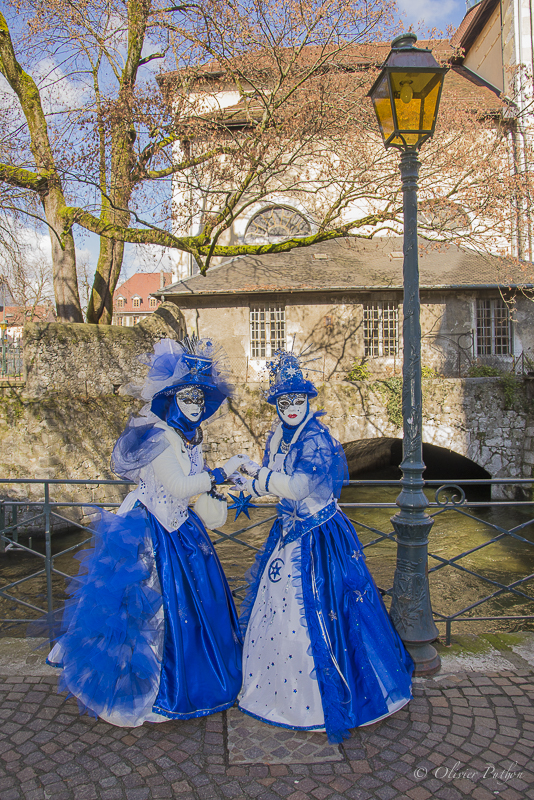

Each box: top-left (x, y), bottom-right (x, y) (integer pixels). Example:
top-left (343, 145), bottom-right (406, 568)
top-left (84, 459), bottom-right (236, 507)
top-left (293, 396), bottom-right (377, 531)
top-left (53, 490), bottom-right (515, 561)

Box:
top-left (48, 339), bottom-right (247, 727)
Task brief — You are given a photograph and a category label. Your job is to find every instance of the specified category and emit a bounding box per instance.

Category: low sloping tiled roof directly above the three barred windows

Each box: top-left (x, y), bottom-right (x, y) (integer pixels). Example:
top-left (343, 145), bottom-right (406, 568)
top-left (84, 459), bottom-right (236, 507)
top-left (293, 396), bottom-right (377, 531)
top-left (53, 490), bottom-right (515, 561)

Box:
top-left (158, 237), bottom-right (532, 299)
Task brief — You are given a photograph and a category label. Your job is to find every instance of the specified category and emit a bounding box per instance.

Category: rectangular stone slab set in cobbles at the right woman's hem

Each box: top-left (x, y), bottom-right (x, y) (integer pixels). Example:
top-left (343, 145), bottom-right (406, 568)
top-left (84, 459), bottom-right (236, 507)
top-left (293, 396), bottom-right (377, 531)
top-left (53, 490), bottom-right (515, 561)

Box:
top-left (226, 708), bottom-right (344, 764)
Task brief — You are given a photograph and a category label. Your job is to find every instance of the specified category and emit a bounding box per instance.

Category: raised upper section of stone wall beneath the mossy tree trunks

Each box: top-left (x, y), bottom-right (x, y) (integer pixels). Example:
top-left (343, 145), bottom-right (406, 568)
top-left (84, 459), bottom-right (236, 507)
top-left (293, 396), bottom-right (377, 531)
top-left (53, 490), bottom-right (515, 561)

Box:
top-left (24, 303), bottom-right (185, 398)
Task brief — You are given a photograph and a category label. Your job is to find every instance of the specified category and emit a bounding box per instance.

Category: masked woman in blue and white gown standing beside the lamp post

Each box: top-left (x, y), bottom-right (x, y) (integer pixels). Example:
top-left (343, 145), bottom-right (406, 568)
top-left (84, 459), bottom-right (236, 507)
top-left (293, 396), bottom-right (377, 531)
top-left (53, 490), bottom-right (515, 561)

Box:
top-left (239, 352), bottom-right (413, 742)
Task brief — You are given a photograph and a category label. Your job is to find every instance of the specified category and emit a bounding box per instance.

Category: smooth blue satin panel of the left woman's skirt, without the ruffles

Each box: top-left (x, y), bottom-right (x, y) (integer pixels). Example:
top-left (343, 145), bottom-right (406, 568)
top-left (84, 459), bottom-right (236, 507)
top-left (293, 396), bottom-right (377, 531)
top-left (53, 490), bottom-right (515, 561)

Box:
top-left (147, 511), bottom-right (241, 719)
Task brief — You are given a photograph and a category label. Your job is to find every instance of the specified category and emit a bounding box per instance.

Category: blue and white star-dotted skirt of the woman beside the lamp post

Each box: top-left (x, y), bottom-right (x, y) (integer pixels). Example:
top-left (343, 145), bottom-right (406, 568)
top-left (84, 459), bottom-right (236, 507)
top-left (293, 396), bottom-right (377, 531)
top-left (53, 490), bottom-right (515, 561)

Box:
top-left (239, 511), bottom-right (413, 742)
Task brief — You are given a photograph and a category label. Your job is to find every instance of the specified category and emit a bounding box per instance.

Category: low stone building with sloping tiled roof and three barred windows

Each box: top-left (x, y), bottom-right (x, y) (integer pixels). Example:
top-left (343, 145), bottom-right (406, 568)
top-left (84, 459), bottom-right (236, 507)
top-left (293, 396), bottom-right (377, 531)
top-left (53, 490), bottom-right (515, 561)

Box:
top-left (155, 237), bottom-right (534, 383)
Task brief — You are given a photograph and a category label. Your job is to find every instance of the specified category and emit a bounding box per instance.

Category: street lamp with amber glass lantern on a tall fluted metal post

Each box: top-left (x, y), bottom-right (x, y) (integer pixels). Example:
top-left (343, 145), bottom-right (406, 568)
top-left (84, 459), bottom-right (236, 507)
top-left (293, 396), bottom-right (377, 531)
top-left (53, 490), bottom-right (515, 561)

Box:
top-left (369, 33), bottom-right (446, 675)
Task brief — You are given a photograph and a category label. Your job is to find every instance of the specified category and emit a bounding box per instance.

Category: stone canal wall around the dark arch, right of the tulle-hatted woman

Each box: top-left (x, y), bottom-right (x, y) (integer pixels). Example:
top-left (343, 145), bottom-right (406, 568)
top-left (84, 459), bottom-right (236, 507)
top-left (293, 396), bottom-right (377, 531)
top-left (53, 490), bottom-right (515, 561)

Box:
top-left (200, 377), bottom-right (534, 496)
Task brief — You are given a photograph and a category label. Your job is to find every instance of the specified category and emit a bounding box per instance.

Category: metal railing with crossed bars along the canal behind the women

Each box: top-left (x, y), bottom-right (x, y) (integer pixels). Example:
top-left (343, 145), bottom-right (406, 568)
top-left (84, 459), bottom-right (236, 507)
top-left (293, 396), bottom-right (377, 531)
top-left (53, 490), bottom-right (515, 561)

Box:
top-left (0, 479), bottom-right (534, 644)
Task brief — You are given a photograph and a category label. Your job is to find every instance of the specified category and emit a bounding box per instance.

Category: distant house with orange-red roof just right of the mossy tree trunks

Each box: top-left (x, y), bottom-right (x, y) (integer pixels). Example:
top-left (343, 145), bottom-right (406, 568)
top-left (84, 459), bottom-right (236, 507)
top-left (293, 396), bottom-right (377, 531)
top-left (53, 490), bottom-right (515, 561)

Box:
top-left (111, 271), bottom-right (172, 327)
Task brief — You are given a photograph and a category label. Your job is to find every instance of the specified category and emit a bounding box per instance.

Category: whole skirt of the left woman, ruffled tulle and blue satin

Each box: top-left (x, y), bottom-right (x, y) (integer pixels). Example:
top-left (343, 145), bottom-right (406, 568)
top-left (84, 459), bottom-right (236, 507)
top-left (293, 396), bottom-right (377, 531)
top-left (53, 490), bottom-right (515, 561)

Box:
top-left (48, 506), bottom-right (241, 727)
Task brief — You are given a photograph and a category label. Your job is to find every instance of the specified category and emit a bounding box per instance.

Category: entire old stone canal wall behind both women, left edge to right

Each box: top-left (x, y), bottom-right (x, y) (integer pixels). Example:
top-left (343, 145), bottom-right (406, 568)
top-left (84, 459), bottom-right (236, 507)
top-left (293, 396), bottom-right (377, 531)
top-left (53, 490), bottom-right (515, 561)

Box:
top-left (0, 322), bottom-right (534, 528)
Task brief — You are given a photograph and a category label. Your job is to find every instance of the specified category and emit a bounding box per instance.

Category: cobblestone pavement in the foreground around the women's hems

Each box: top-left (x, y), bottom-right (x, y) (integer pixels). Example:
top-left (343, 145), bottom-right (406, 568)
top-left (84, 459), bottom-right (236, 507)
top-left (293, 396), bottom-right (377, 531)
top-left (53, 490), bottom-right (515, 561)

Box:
top-left (0, 670), bottom-right (534, 800)
